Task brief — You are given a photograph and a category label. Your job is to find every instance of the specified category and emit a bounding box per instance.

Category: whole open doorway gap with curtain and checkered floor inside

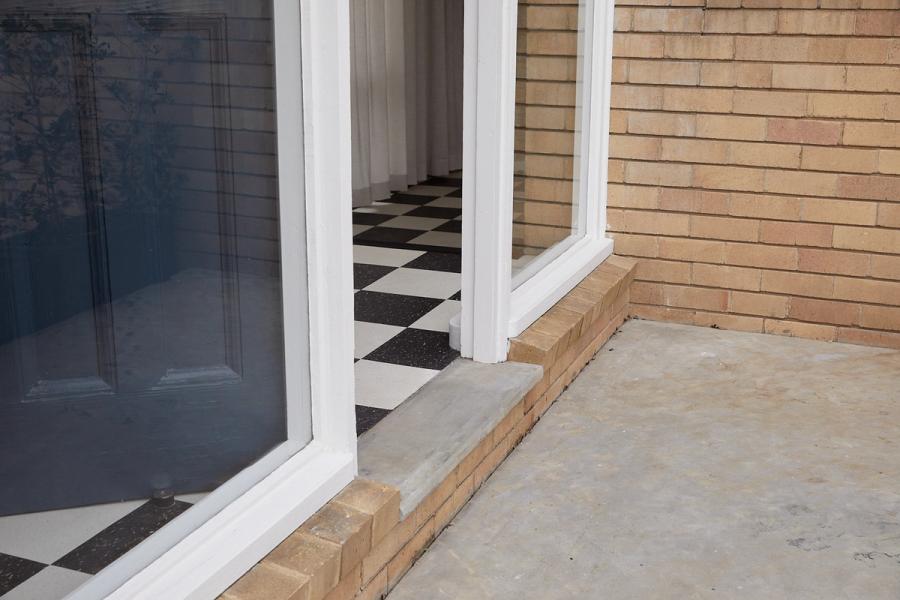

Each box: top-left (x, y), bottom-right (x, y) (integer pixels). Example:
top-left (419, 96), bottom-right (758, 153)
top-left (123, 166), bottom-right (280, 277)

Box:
top-left (350, 0), bottom-right (463, 434)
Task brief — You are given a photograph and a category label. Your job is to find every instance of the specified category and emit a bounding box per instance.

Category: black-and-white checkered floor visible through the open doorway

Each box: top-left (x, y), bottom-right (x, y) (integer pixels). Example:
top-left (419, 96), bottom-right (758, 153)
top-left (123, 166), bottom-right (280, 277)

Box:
top-left (353, 177), bottom-right (462, 434)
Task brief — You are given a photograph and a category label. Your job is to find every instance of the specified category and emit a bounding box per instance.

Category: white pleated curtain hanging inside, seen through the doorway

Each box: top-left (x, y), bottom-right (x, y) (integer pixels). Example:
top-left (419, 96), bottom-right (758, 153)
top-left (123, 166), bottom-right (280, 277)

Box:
top-left (350, 0), bottom-right (464, 206)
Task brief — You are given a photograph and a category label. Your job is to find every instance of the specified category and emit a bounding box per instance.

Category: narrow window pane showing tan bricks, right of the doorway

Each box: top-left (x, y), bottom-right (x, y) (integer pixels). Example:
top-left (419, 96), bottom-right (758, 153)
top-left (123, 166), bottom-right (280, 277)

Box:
top-left (512, 0), bottom-right (585, 287)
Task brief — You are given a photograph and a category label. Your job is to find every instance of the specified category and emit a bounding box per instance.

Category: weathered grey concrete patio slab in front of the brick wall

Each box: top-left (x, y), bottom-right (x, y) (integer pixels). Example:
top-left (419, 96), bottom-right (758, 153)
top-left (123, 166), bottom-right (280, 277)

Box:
top-left (389, 321), bottom-right (900, 600)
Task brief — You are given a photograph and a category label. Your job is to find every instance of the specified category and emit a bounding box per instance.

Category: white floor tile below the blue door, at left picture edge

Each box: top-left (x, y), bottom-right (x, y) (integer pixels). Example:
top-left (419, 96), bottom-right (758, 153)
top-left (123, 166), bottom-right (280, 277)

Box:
top-left (0, 500), bottom-right (145, 564)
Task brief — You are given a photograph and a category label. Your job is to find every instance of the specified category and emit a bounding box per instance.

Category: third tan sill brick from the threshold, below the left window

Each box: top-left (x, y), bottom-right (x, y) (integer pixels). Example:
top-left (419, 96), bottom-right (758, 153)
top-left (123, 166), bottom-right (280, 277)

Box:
top-left (263, 529), bottom-right (341, 600)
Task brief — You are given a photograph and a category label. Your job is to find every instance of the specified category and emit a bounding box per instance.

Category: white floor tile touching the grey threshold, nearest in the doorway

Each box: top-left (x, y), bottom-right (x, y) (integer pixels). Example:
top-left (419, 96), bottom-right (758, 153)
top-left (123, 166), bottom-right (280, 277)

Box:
top-left (353, 360), bottom-right (440, 410)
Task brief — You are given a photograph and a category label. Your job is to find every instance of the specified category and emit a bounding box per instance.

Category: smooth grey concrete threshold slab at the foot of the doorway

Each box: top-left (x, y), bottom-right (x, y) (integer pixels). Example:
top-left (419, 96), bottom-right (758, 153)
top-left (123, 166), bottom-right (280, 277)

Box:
top-left (359, 359), bottom-right (543, 517)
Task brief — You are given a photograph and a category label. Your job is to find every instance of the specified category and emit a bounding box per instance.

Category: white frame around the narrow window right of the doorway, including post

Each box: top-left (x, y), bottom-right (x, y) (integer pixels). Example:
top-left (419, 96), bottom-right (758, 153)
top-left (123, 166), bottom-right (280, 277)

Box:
top-left (460, 0), bottom-right (614, 362)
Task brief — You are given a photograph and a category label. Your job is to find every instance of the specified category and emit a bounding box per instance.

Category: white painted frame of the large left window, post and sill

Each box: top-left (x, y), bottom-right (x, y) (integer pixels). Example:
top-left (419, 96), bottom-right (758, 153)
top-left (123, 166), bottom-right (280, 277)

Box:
top-left (70, 0), bottom-right (357, 600)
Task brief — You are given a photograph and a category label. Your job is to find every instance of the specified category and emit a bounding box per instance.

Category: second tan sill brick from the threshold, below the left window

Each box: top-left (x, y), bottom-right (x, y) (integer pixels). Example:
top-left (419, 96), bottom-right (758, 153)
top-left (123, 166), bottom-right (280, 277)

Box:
top-left (300, 502), bottom-right (372, 576)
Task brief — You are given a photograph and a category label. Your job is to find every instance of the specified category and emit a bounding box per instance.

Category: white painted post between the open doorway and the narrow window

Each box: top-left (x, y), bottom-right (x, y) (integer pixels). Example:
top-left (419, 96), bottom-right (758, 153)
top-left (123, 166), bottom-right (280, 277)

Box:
top-left (460, 0), bottom-right (518, 362)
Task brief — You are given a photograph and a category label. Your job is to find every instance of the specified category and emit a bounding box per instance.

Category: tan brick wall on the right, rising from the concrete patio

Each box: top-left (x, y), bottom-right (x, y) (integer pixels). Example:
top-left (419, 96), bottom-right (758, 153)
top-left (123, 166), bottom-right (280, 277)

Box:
top-left (608, 0), bottom-right (900, 347)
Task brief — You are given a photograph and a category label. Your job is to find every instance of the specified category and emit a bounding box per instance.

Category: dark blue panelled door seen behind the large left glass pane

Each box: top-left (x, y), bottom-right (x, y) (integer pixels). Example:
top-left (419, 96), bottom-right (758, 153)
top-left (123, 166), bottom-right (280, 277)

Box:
top-left (0, 0), bottom-right (296, 515)
